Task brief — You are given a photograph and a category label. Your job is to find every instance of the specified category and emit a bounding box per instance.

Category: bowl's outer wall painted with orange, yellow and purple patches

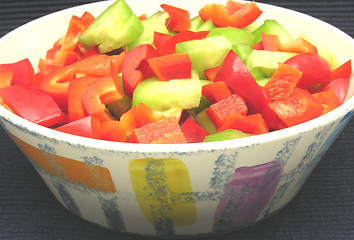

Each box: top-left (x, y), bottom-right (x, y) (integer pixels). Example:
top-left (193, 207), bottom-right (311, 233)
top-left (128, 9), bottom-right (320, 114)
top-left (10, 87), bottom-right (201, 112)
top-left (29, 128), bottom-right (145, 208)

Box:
top-left (1, 111), bottom-right (353, 237)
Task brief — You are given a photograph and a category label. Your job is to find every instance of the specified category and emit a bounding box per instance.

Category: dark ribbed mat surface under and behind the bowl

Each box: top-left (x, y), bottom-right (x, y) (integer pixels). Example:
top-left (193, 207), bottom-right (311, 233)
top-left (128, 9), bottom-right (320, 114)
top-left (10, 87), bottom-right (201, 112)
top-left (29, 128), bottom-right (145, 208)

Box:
top-left (0, 0), bottom-right (354, 240)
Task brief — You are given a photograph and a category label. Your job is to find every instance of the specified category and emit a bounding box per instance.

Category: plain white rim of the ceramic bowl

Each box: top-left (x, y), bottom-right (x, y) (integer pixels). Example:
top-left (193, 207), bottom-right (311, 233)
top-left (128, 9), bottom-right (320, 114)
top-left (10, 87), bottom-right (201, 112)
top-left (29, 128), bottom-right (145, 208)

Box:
top-left (0, 0), bottom-right (354, 153)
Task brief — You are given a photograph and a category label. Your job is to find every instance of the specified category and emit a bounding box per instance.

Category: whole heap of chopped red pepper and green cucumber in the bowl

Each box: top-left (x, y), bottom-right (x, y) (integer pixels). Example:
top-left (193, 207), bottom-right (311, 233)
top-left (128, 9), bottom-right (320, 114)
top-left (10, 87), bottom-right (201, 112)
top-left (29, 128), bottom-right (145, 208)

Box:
top-left (0, 0), bottom-right (352, 144)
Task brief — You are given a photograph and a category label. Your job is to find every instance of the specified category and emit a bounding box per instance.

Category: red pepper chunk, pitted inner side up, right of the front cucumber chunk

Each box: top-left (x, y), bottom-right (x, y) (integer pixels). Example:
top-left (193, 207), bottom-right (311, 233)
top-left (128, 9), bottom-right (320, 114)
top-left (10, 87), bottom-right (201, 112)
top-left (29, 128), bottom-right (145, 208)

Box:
top-left (206, 94), bottom-right (248, 127)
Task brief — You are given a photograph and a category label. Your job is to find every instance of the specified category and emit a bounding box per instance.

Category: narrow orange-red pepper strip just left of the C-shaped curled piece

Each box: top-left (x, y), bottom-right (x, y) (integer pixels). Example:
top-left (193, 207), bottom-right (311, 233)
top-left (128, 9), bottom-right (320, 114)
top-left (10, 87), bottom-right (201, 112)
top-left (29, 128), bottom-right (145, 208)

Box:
top-left (68, 77), bottom-right (97, 122)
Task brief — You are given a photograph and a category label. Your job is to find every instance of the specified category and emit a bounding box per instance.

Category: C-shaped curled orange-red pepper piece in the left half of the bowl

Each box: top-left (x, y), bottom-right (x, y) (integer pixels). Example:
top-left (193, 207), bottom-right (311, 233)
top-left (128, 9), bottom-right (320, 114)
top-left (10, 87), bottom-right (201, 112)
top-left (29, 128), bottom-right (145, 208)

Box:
top-left (83, 76), bottom-right (123, 121)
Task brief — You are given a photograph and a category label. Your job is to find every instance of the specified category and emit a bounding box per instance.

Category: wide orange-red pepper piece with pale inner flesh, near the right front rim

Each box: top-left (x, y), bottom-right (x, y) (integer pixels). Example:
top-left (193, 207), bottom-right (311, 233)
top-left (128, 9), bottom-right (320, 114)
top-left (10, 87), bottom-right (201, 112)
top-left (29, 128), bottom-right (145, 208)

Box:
top-left (269, 88), bottom-right (324, 127)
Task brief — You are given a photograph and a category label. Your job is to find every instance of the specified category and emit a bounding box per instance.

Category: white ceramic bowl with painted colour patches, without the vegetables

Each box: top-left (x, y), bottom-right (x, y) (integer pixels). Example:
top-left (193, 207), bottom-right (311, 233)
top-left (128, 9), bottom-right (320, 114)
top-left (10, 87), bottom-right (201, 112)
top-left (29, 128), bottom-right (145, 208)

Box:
top-left (0, 0), bottom-right (354, 238)
